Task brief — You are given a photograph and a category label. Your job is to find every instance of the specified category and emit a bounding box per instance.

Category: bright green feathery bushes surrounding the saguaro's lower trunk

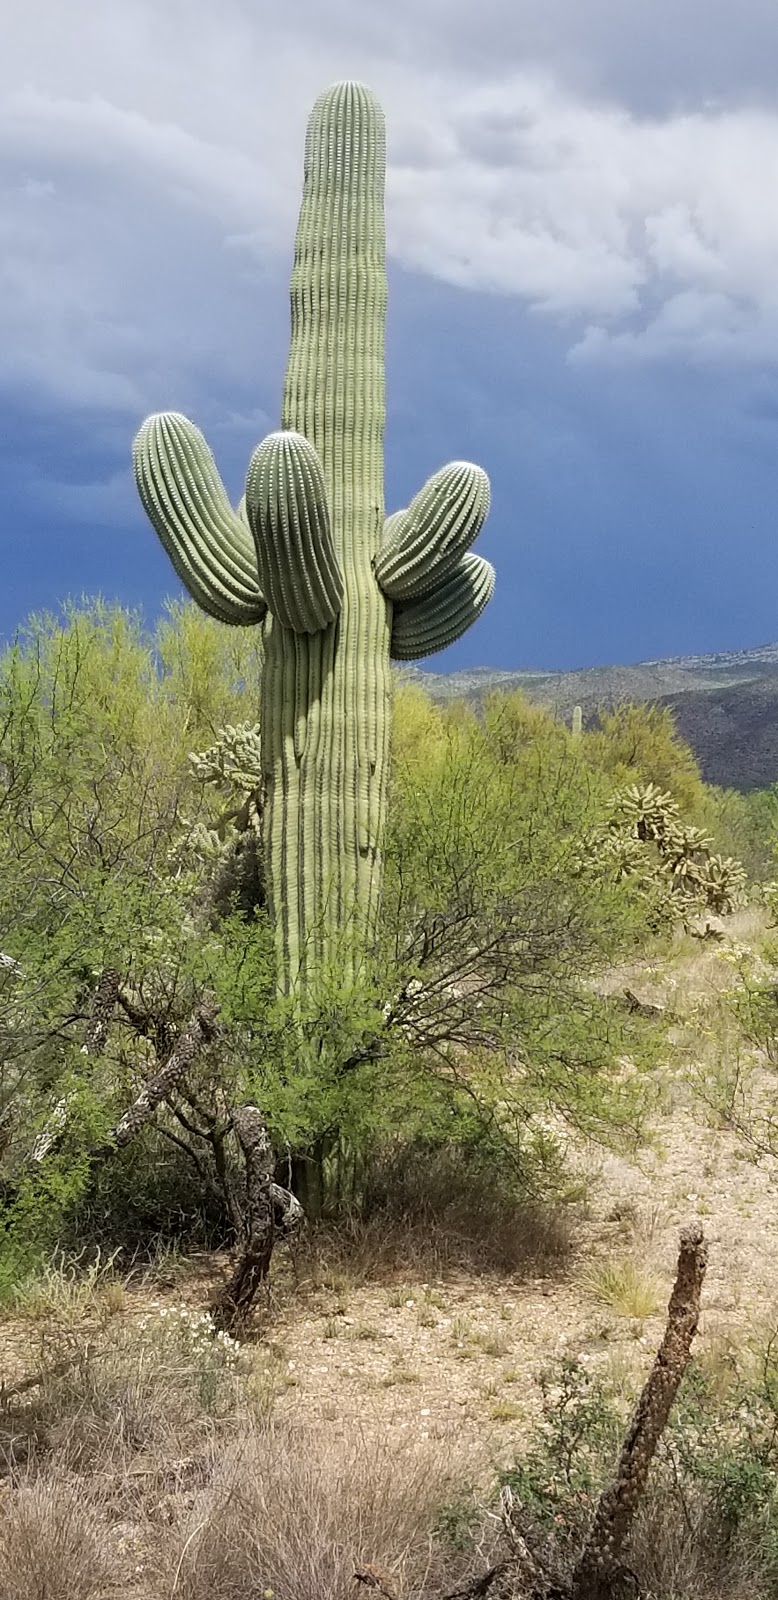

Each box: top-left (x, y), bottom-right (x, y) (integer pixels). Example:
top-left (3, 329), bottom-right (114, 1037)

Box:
top-left (0, 606), bottom-right (669, 1278)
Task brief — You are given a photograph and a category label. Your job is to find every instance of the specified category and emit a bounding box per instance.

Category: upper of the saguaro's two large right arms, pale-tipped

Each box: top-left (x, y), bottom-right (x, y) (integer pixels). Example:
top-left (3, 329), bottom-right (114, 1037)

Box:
top-left (375, 461), bottom-right (490, 602)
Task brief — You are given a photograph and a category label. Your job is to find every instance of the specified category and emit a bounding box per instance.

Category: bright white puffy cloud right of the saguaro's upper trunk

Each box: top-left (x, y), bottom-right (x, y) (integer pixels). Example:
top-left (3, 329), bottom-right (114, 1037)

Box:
top-left (391, 78), bottom-right (778, 358)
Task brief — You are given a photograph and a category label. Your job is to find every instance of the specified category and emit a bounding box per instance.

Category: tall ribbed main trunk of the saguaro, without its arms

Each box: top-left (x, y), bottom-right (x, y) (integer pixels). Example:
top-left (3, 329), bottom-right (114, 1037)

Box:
top-left (261, 83), bottom-right (392, 976)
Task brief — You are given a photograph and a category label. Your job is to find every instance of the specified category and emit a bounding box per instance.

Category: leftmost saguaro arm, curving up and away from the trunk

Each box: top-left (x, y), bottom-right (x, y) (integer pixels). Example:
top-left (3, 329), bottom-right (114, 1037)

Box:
top-left (133, 411), bottom-right (267, 626)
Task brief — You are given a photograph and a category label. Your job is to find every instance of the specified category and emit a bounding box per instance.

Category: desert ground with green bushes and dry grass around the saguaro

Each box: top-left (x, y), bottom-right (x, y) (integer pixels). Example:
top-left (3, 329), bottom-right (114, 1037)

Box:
top-left (0, 605), bottom-right (778, 1600)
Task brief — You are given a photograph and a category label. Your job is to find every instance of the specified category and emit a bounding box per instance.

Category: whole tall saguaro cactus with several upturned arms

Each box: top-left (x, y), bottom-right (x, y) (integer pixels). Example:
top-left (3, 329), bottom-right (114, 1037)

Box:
top-left (133, 83), bottom-right (495, 989)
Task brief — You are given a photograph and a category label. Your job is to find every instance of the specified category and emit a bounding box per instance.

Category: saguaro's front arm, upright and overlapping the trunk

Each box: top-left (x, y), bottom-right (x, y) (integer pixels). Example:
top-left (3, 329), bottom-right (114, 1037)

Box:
top-left (245, 430), bottom-right (343, 634)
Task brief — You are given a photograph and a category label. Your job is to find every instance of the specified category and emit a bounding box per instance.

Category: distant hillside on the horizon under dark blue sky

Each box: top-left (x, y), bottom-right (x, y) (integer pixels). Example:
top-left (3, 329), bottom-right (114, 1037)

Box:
top-left (400, 643), bottom-right (778, 792)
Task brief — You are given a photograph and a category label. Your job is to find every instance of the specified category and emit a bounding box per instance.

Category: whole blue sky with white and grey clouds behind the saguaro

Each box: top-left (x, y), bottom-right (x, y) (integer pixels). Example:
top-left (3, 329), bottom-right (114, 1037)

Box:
top-left (0, 0), bottom-right (778, 670)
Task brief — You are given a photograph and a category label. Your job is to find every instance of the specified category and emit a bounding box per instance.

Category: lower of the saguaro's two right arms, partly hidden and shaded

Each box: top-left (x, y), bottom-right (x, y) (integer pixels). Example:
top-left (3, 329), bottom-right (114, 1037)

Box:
top-left (391, 554), bottom-right (495, 661)
